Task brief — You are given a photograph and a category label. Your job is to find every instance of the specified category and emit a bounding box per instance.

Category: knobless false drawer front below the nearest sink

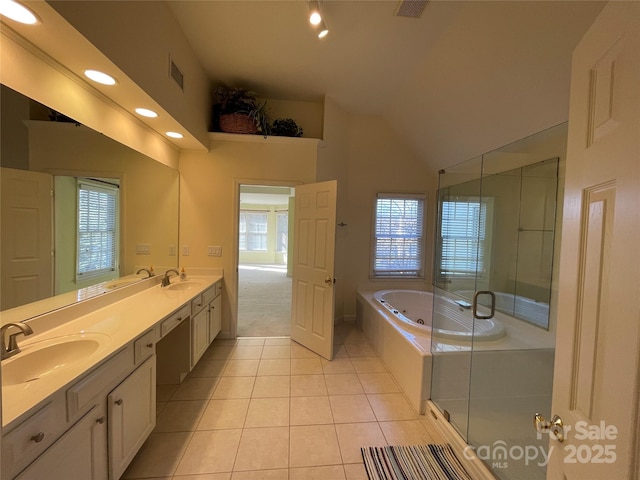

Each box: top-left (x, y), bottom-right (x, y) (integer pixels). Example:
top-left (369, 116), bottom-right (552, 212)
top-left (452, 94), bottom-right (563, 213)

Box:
top-left (67, 344), bottom-right (133, 420)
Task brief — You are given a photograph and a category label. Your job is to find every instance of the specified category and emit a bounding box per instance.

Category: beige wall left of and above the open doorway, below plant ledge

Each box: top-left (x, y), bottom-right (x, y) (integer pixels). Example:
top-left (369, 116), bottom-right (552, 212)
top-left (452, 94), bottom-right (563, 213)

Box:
top-left (180, 135), bottom-right (318, 336)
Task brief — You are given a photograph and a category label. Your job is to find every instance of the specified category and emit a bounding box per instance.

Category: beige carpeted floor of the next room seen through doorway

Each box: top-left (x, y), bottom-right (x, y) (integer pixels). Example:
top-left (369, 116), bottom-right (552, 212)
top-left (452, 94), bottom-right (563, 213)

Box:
top-left (238, 265), bottom-right (291, 337)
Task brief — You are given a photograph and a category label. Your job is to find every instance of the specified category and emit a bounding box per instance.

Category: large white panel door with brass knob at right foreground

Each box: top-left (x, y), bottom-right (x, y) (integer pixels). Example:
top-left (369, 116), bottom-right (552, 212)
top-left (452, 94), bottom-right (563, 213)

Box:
top-left (547, 1), bottom-right (640, 480)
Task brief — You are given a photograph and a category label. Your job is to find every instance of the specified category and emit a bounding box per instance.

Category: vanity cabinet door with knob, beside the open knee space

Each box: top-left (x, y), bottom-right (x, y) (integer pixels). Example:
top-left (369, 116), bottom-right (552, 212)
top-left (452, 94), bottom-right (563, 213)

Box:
top-left (107, 356), bottom-right (156, 480)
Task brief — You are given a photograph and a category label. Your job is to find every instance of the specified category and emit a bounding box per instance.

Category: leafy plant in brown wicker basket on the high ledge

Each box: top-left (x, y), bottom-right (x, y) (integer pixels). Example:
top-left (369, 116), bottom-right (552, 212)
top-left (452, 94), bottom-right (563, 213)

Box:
top-left (216, 87), bottom-right (269, 135)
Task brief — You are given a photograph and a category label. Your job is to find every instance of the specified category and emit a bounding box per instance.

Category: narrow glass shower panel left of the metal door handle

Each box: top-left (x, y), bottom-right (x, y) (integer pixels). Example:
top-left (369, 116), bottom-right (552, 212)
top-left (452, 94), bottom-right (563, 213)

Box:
top-left (431, 157), bottom-right (486, 440)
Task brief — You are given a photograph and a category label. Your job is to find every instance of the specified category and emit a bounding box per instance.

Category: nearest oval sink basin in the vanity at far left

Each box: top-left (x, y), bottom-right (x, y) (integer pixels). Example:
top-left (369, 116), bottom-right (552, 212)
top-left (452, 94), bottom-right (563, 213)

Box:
top-left (2, 334), bottom-right (108, 386)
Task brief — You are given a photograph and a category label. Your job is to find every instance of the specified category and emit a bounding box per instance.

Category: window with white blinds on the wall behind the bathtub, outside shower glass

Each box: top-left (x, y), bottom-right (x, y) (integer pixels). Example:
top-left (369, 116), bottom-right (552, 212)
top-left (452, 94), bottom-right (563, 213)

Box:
top-left (372, 194), bottom-right (424, 278)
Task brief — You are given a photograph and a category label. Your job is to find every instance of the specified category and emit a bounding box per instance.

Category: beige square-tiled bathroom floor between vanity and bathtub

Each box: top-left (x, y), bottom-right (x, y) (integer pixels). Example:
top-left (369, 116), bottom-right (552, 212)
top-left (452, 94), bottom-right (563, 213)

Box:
top-left (122, 324), bottom-right (443, 480)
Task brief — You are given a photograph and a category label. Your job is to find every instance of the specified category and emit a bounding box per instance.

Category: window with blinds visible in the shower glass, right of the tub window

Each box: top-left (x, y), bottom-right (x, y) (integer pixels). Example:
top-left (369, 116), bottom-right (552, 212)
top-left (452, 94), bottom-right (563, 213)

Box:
top-left (440, 198), bottom-right (489, 276)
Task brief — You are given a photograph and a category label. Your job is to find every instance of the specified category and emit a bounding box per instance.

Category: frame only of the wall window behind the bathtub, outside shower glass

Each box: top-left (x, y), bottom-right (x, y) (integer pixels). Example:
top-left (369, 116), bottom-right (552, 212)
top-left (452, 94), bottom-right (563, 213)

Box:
top-left (369, 193), bottom-right (427, 281)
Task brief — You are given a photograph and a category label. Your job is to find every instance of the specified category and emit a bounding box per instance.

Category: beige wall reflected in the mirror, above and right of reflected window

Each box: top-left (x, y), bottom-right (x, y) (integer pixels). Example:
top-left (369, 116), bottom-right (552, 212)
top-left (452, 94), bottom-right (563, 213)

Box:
top-left (29, 121), bottom-right (179, 275)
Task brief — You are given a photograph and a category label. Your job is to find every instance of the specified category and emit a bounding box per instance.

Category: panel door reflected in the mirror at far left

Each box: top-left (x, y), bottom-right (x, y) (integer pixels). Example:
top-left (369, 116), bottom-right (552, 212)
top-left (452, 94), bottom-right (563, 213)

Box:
top-left (0, 168), bottom-right (53, 310)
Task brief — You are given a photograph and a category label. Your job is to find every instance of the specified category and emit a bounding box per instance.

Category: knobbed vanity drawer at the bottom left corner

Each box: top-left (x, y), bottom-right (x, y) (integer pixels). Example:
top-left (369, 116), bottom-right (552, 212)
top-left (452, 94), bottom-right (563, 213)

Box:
top-left (2, 402), bottom-right (65, 478)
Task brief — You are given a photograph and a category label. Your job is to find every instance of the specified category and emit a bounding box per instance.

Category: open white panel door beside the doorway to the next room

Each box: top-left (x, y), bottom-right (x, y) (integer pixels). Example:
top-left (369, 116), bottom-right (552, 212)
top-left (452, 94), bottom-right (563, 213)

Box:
top-left (291, 180), bottom-right (338, 360)
